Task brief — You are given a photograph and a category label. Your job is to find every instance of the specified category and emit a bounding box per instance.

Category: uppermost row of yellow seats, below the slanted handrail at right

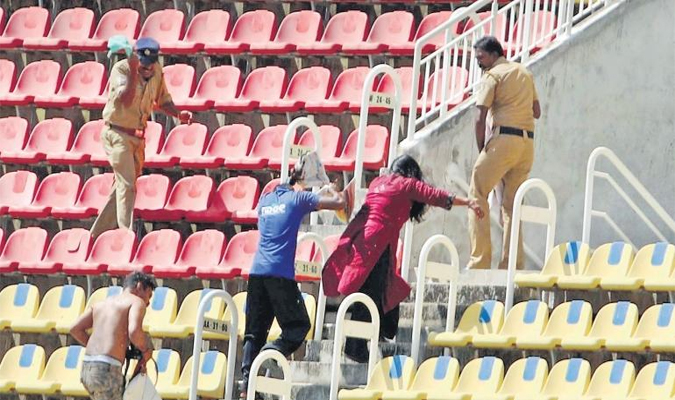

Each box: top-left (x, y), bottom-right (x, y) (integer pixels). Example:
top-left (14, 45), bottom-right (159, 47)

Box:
top-left (515, 242), bottom-right (675, 291)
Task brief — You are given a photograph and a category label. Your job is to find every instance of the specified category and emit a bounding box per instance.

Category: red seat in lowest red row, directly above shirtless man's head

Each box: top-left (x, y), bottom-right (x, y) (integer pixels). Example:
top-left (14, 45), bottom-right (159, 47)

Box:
top-left (108, 229), bottom-right (183, 275)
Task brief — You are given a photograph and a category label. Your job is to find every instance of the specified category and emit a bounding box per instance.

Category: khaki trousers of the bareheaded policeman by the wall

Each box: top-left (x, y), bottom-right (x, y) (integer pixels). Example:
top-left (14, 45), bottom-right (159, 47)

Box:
top-left (468, 134), bottom-right (534, 269)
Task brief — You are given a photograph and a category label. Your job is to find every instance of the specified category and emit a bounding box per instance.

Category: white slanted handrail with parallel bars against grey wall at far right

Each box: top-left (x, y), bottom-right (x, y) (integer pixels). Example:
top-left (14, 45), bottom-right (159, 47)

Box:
top-left (581, 147), bottom-right (675, 245)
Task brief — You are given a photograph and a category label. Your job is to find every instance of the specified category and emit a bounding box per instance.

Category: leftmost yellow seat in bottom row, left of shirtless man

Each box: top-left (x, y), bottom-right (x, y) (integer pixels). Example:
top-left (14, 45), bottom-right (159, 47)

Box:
top-left (0, 344), bottom-right (45, 393)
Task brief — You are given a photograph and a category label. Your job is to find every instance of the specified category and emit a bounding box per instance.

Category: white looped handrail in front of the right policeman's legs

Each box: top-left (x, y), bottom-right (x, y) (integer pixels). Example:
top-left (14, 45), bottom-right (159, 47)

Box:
top-left (504, 178), bottom-right (558, 315)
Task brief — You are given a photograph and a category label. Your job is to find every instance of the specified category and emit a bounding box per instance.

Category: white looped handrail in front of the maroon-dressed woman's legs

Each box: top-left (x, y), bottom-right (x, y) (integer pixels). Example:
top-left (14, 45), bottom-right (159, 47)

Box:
top-left (330, 293), bottom-right (380, 400)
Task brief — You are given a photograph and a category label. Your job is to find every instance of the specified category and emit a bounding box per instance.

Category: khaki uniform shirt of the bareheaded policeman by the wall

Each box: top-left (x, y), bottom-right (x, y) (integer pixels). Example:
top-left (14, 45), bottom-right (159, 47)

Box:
top-left (476, 57), bottom-right (538, 131)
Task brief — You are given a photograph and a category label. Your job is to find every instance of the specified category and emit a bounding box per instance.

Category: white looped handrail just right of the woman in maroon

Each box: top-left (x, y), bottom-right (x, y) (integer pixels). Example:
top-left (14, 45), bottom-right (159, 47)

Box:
top-left (410, 235), bottom-right (459, 365)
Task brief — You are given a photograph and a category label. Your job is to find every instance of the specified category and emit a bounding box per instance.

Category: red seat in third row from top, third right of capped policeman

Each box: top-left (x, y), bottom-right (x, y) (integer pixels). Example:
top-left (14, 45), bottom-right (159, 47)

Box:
top-left (180, 124), bottom-right (253, 168)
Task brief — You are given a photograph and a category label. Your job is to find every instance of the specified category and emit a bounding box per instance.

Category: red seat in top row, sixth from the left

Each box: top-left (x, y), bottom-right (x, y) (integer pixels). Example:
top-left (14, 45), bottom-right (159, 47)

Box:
top-left (204, 10), bottom-right (276, 54)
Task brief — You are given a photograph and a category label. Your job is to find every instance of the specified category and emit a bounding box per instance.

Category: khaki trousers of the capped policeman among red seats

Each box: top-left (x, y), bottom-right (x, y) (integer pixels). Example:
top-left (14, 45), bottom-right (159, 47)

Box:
top-left (91, 125), bottom-right (145, 238)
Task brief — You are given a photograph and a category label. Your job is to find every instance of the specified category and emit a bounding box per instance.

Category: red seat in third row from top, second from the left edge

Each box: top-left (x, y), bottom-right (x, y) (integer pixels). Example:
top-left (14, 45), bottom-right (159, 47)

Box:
top-left (0, 118), bottom-right (73, 164)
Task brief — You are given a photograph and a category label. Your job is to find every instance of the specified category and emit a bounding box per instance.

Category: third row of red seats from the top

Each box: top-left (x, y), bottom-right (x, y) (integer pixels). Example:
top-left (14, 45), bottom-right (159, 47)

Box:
top-left (0, 117), bottom-right (389, 170)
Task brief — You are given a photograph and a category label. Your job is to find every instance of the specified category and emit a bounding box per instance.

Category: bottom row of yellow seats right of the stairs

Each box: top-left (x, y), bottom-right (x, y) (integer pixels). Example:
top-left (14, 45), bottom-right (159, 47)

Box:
top-left (338, 356), bottom-right (675, 400)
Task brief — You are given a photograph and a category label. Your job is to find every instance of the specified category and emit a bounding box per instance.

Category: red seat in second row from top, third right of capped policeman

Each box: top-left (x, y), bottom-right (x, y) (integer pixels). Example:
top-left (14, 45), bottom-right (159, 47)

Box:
top-left (215, 66), bottom-right (287, 112)
